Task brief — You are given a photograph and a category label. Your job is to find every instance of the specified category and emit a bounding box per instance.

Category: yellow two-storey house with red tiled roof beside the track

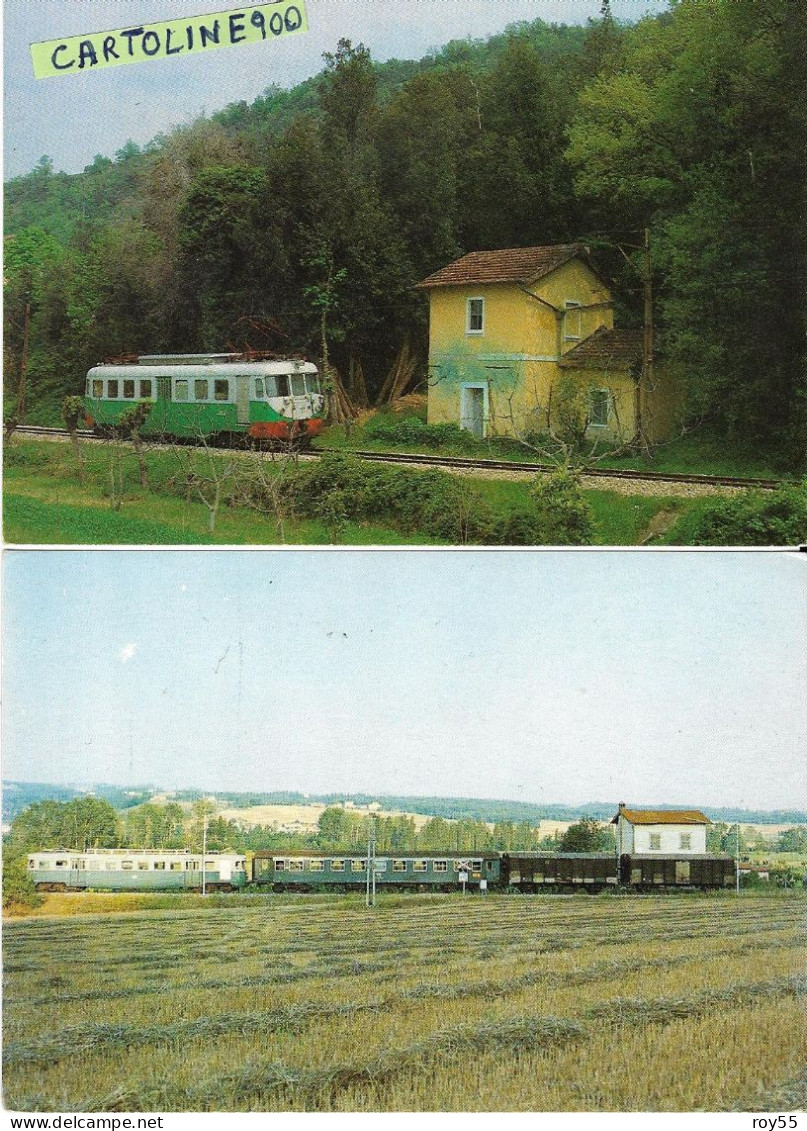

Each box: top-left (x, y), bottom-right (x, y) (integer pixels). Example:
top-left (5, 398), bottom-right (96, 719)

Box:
top-left (418, 243), bottom-right (674, 442)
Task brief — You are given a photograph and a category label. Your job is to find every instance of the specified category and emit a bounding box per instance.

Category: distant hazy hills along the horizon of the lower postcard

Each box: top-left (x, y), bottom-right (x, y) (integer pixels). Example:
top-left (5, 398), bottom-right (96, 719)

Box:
top-left (2, 782), bottom-right (807, 824)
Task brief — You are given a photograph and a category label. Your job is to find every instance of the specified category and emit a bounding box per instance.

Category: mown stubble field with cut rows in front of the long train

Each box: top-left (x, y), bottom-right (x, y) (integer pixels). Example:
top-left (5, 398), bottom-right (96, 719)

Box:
top-left (3, 892), bottom-right (806, 1112)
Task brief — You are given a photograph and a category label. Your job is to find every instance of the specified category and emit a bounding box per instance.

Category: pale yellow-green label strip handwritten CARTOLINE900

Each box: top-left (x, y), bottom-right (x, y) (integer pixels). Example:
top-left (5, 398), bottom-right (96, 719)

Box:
top-left (31, 0), bottom-right (309, 78)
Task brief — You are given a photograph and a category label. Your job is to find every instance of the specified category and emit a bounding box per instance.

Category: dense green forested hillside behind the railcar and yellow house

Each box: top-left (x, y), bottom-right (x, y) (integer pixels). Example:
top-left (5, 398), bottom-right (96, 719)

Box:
top-left (5, 0), bottom-right (807, 468)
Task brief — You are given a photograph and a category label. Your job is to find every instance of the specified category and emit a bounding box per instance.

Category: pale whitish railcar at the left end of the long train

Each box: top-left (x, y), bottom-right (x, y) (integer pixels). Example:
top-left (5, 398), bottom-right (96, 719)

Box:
top-left (28, 848), bottom-right (246, 891)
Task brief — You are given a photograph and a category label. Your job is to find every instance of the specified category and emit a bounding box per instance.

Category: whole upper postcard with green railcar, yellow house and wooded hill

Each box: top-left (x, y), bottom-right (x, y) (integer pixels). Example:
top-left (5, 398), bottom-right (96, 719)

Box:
top-left (3, 0), bottom-right (807, 546)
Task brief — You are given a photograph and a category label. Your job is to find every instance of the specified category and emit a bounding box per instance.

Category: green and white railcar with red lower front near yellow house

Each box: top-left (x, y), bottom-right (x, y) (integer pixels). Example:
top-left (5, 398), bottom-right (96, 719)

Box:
top-left (85, 354), bottom-right (327, 442)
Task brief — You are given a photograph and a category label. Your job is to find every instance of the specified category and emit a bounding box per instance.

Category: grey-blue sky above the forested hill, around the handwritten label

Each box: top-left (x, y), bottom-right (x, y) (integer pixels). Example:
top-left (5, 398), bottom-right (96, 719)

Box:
top-left (3, 0), bottom-right (667, 179)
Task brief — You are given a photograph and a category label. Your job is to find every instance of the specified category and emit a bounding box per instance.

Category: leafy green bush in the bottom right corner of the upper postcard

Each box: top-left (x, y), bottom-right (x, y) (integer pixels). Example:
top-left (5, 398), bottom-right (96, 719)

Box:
top-left (689, 483), bottom-right (807, 546)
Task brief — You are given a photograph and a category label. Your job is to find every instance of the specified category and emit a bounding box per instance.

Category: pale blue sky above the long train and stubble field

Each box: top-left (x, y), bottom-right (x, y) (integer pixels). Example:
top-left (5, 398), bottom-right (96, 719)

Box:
top-left (2, 550), bottom-right (807, 812)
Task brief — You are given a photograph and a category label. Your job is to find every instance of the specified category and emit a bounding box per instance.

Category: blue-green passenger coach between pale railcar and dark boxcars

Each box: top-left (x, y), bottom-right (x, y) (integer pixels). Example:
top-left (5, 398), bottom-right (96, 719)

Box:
top-left (252, 852), bottom-right (501, 891)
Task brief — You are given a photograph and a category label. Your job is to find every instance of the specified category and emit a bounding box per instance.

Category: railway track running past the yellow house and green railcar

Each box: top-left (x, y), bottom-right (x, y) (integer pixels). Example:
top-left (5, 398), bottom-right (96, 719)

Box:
top-left (16, 424), bottom-right (782, 491)
